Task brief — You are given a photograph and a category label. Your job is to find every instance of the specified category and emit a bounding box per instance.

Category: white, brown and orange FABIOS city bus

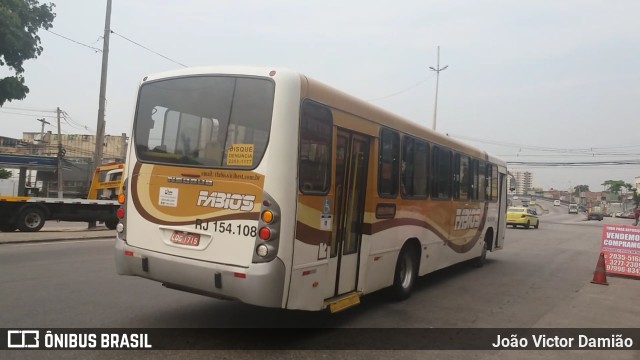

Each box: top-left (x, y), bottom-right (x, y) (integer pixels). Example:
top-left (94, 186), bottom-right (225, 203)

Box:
top-left (116, 67), bottom-right (507, 311)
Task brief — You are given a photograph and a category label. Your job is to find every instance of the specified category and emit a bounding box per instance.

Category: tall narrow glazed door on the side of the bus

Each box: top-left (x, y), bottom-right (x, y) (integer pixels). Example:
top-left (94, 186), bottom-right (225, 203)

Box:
top-left (327, 129), bottom-right (370, 296)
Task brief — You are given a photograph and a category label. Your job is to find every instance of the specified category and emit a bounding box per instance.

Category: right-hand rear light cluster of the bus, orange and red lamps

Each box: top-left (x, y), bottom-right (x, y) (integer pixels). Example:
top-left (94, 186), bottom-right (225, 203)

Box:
top-left (253, 193), bottom-right (280, 262)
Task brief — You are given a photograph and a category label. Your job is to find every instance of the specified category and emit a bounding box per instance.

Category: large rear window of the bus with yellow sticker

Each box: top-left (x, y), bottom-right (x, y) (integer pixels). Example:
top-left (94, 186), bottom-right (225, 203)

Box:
top-left (134, 76), bottom-right (275, 169)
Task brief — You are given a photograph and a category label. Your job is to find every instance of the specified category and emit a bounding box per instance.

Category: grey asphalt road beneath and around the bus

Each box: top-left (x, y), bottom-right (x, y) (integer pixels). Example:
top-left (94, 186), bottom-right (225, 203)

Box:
top-left (0, 201), bottom-right (640, 359)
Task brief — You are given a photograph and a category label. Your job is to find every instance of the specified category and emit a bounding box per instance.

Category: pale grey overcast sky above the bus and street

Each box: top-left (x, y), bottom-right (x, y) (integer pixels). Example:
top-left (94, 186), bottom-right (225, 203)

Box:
top-left (0, 0), bottom-right (640, 191)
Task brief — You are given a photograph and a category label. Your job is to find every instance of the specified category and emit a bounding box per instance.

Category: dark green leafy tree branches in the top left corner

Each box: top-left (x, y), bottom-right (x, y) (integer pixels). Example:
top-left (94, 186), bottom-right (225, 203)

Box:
top-left (0, 0), bottom-right (56, 106)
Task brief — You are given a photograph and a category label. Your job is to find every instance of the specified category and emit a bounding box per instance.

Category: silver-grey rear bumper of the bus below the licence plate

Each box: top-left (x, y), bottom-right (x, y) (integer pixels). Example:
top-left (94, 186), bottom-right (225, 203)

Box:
top-left (115, 238), bottom-right (285, 308)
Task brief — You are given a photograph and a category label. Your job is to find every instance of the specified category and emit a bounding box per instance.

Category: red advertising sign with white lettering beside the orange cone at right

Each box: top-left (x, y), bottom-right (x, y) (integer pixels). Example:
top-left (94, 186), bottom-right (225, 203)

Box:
top-left (600, 224), bottom-right (640, 277)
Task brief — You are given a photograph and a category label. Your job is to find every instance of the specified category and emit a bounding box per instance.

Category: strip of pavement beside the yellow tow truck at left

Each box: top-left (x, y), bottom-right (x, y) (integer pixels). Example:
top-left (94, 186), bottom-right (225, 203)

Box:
top-left (0, 221), bottom-right (116, 245)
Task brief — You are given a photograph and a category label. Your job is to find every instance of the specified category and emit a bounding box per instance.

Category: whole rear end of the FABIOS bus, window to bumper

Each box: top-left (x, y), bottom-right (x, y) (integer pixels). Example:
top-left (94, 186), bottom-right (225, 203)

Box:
top-left (116, 68), bottom-right (299, 307)
